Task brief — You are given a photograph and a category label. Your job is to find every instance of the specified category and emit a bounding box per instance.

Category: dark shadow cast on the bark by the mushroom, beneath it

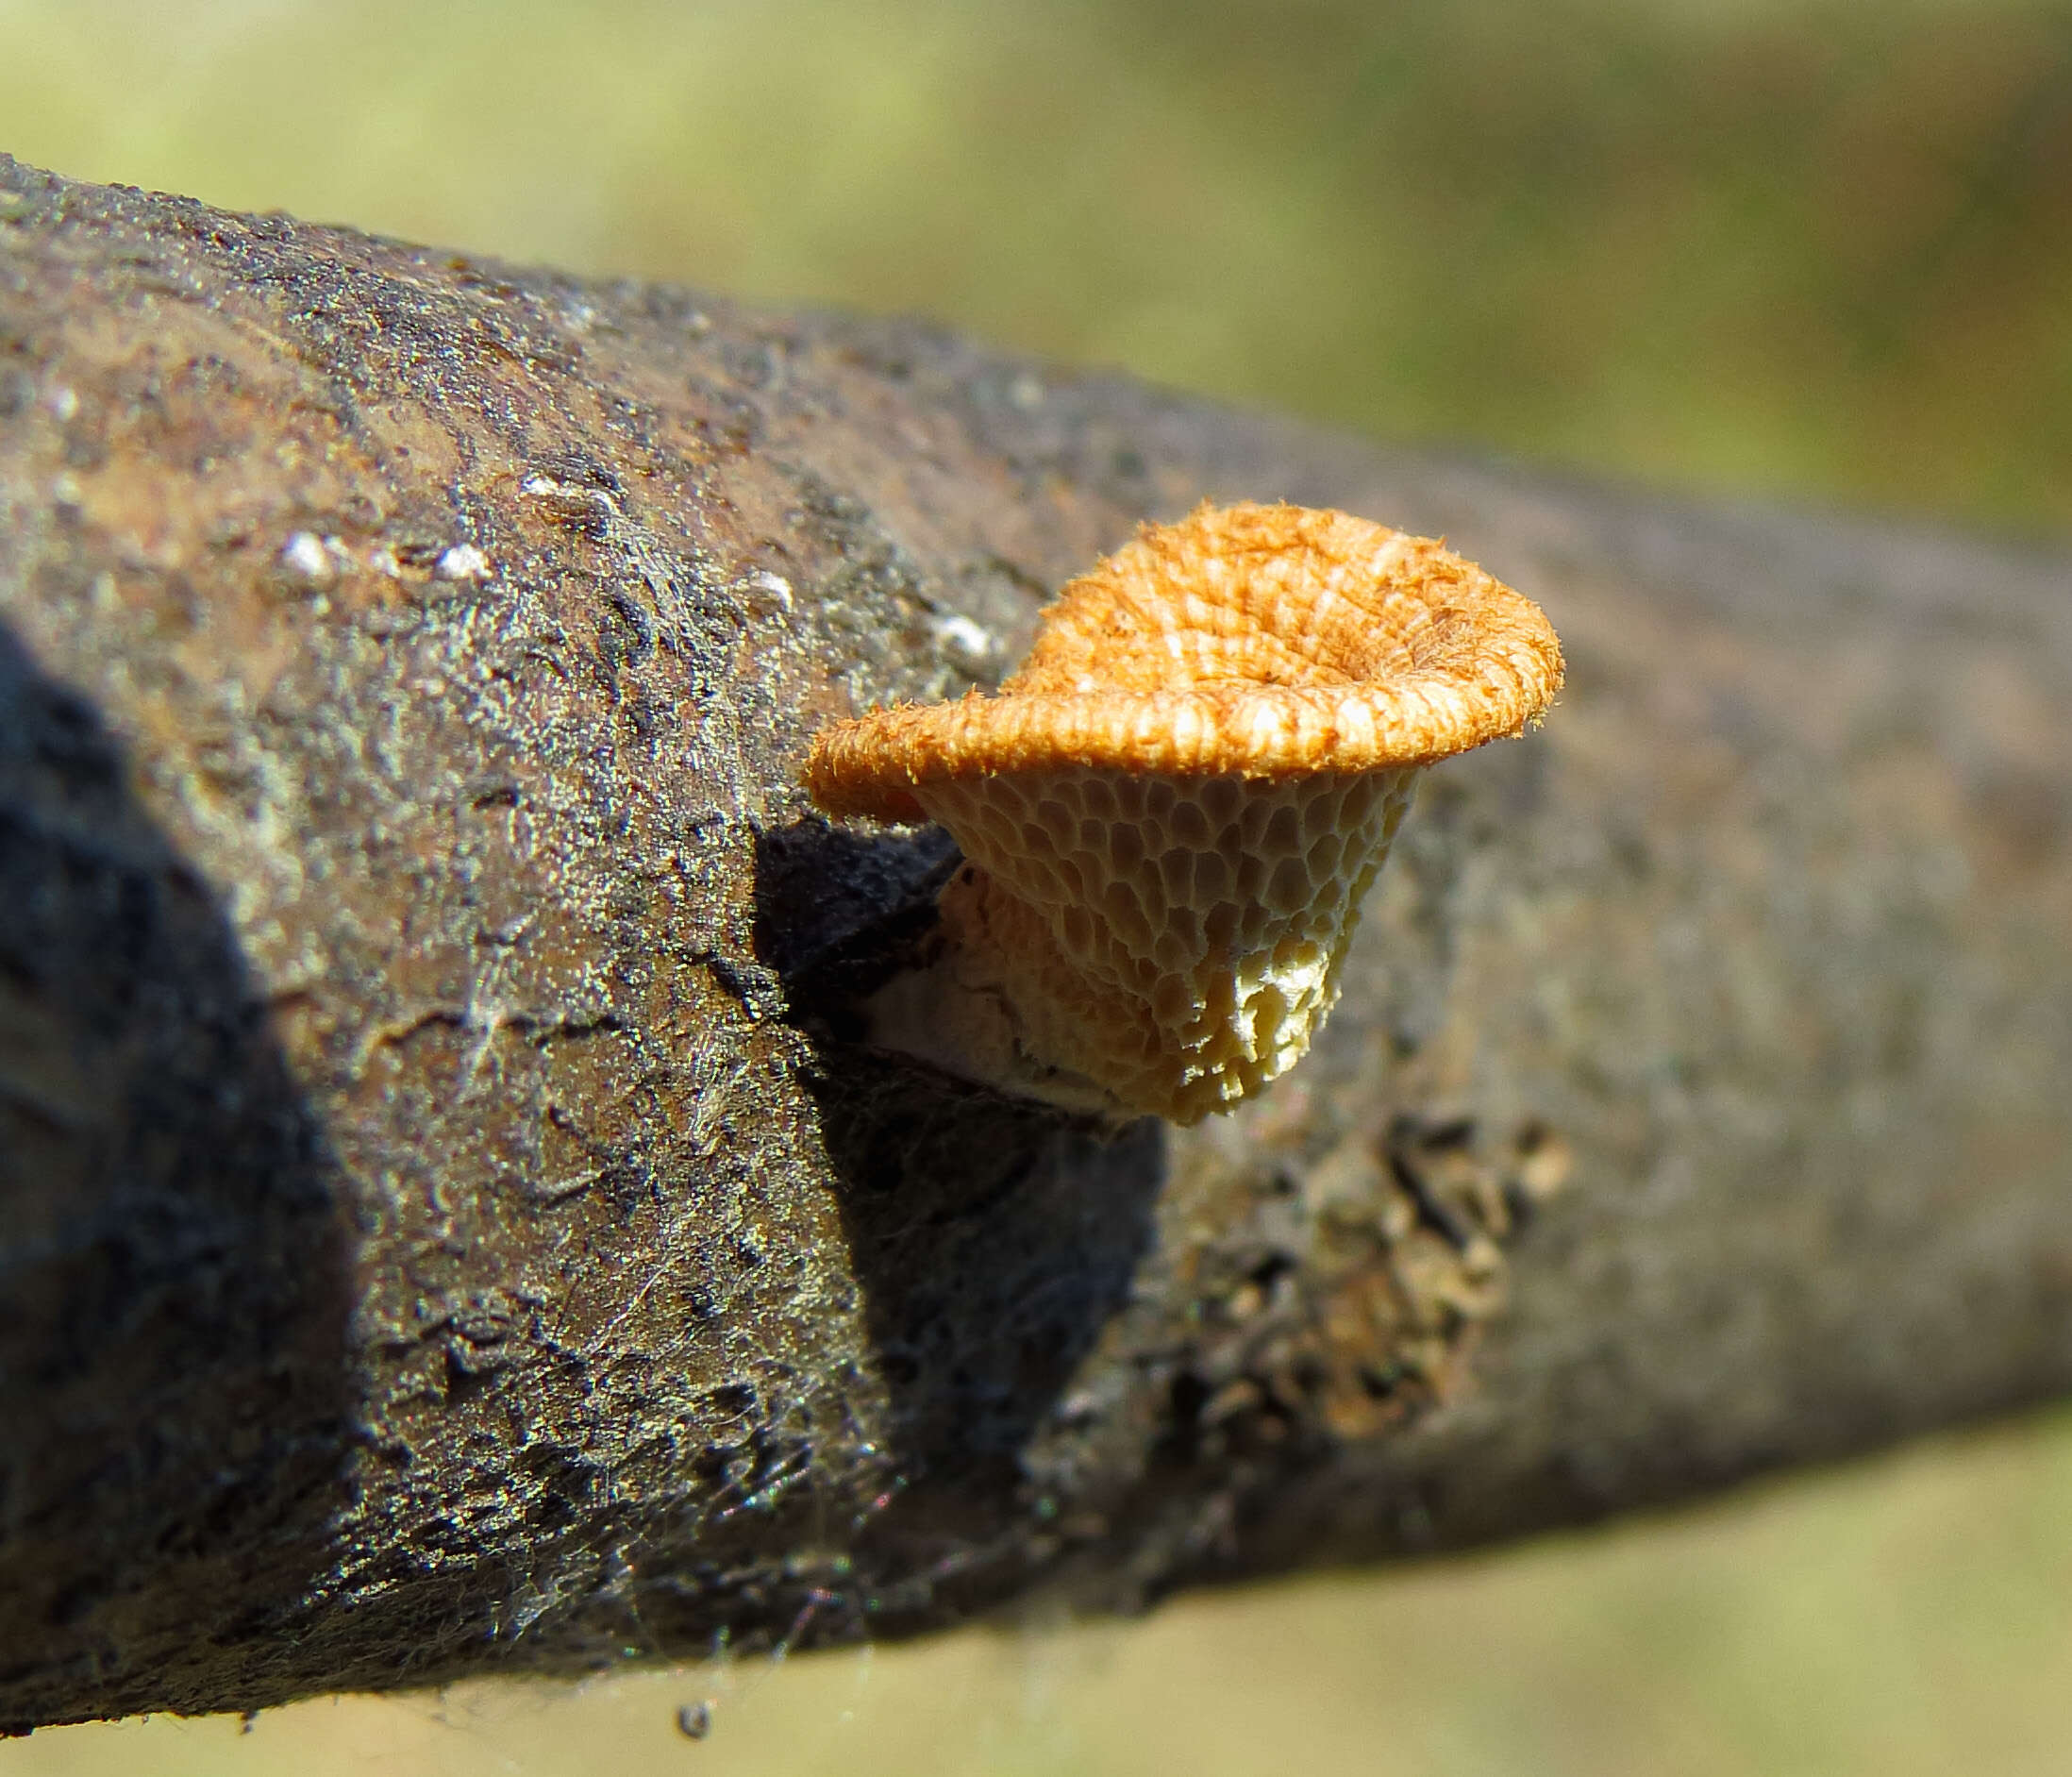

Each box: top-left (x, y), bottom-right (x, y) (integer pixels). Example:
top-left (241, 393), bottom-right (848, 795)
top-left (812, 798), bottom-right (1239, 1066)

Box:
top-left (757, 821), bottom-right (1166, 1555)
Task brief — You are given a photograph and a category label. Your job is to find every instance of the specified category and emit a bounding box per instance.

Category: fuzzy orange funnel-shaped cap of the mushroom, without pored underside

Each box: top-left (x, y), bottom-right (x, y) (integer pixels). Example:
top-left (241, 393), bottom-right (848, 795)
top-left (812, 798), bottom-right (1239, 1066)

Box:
top-left (806, 504), bottom-right (1562, 821)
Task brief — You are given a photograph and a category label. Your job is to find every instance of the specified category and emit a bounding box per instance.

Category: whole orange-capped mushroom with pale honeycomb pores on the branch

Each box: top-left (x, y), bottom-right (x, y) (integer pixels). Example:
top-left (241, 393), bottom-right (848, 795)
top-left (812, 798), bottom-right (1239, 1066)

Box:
top-left (806, 504), bottom-right (1562, 1124)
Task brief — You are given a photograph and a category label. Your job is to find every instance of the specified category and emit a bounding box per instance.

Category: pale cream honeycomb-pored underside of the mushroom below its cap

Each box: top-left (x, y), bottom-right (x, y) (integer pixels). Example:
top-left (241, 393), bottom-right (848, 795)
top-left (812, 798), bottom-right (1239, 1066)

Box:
top-left (918, 767), bottom-right (1419, 1124)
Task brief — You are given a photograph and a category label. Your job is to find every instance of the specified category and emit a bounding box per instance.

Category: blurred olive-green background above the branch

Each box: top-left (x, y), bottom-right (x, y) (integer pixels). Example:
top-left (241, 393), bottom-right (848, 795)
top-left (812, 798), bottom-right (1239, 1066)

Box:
top-left (0, 0), bottom-right (2072, 528)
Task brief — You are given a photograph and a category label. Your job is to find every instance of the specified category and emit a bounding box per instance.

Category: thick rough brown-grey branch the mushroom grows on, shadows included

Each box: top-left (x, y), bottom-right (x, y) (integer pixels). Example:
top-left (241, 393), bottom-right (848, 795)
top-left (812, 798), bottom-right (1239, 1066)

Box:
top-left (0, 161), bottom-right (2072, 1727)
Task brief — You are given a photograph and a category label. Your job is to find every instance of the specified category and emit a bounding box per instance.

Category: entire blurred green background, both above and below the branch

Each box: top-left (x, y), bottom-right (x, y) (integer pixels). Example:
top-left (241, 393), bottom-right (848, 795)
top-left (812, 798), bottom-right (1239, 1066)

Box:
top-left (0, 0), bottom-right (2072, 1777)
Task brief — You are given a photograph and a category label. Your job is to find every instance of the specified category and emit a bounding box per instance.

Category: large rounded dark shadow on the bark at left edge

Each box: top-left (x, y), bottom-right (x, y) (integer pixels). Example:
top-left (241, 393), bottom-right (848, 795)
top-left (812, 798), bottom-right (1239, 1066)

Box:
top-left (0, 630), bottom-right (352, 1732)
